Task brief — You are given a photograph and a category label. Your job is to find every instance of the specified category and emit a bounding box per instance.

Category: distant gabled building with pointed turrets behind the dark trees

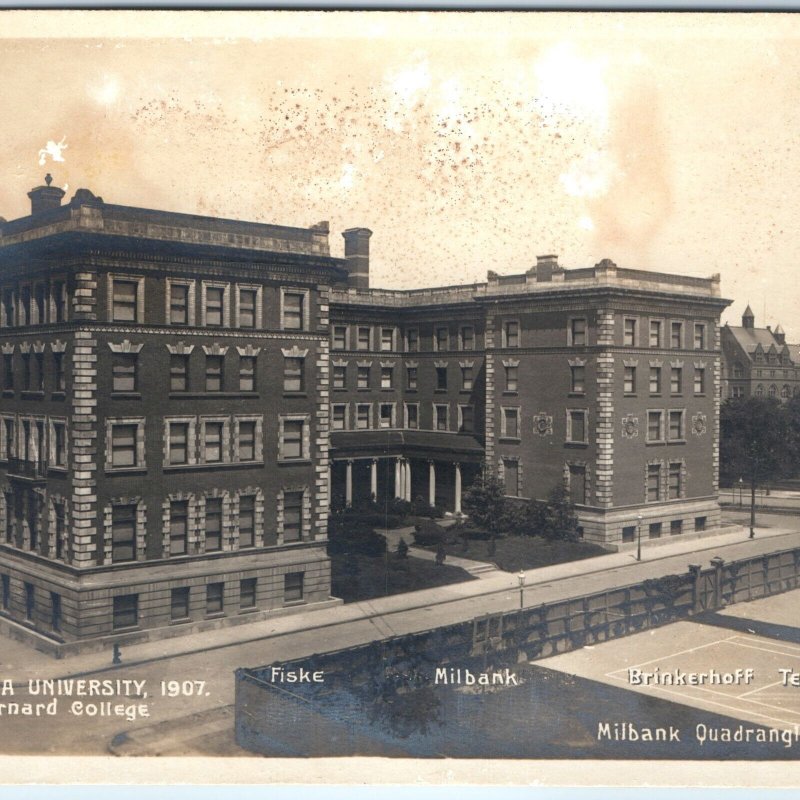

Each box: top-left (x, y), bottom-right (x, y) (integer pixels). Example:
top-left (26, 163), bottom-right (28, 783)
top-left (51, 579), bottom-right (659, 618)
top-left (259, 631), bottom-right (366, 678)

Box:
top-left (721, 305), bottom-right (800, 403)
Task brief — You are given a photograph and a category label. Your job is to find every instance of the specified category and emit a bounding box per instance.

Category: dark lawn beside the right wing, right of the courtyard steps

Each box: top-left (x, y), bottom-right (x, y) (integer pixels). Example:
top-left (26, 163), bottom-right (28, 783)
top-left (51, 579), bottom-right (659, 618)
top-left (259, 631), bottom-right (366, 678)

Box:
top-left (418, 536), bottom-right (608, 572)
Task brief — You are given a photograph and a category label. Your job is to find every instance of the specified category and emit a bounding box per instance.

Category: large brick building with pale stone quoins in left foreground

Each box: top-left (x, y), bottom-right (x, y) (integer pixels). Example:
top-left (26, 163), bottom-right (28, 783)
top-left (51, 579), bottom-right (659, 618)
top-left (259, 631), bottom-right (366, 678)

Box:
top-left (0, 177), bottom-right (346, 649)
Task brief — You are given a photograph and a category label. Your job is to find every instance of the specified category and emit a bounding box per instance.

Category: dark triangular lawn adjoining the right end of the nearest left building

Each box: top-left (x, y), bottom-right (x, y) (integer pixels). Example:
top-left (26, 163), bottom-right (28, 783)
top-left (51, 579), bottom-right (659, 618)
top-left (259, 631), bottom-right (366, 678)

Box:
top-left (331, 553), bottom-right (475, 603)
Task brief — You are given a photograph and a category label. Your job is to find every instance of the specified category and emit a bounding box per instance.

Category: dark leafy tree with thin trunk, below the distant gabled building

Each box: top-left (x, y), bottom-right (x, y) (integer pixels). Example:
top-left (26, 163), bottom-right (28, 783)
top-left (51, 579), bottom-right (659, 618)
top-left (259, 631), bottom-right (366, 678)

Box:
top-left (719, 397), bottom-right (790, 538)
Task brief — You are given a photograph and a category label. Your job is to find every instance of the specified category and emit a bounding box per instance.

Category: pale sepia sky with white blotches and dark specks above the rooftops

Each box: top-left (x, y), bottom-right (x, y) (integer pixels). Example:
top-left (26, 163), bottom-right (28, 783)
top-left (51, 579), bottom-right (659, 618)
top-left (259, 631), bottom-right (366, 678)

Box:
top-left (0, 11), bottom-right (800, 342)
